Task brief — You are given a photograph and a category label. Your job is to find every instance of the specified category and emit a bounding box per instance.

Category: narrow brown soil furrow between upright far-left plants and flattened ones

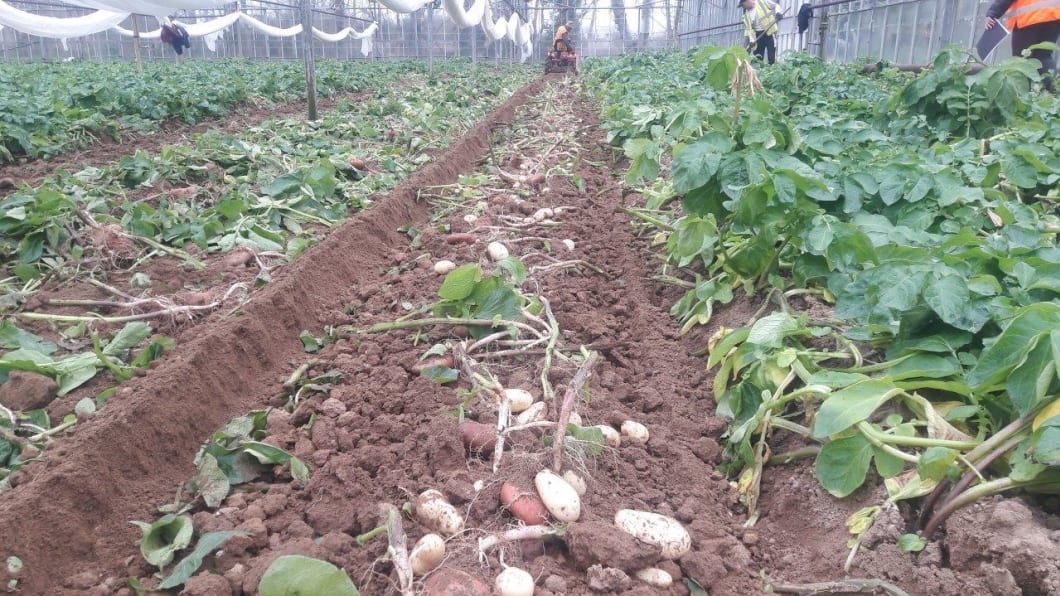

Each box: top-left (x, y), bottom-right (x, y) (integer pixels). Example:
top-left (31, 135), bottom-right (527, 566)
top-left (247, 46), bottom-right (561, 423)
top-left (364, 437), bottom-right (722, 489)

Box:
top-left (0, 89), bottom-right (373, 197)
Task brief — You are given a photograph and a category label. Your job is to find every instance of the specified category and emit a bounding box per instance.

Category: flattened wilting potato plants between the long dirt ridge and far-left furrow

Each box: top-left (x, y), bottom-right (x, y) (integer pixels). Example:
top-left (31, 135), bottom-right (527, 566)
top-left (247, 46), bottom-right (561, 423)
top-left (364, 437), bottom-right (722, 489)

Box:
top-left (0, 63), bottom-right (528, 489)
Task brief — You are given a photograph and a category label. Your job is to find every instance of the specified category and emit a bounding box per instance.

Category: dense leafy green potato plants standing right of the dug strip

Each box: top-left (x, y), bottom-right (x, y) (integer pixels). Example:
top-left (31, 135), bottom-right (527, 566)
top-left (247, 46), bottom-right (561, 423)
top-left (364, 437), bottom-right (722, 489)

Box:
top-left (589, 48), bottom-right (1060, 542)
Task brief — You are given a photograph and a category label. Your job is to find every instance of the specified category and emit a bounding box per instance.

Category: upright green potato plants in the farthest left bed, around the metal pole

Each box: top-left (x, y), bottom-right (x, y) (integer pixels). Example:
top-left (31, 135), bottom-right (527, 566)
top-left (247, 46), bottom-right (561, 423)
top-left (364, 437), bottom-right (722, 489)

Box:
top-left (0, 60), bottom-right (464, 163)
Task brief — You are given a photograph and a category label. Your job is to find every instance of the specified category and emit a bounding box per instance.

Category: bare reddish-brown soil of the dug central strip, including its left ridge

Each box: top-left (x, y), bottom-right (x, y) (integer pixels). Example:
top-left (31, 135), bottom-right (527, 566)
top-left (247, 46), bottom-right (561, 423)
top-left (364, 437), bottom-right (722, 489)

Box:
top-left (0, 74), bottom-right (1060, 596)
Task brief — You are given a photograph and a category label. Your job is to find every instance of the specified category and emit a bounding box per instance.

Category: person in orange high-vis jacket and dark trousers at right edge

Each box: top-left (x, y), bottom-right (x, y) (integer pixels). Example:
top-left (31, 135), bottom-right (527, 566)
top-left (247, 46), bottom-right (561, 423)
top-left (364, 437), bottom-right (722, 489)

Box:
top-left (987, 0), bottom-right (1060, 90)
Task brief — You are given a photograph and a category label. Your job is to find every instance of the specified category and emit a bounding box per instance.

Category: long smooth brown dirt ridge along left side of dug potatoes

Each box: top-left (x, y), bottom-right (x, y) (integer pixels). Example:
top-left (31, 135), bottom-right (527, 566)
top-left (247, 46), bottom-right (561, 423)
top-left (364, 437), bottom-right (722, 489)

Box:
top-left (0, 82), bottom-right (541, 594)
